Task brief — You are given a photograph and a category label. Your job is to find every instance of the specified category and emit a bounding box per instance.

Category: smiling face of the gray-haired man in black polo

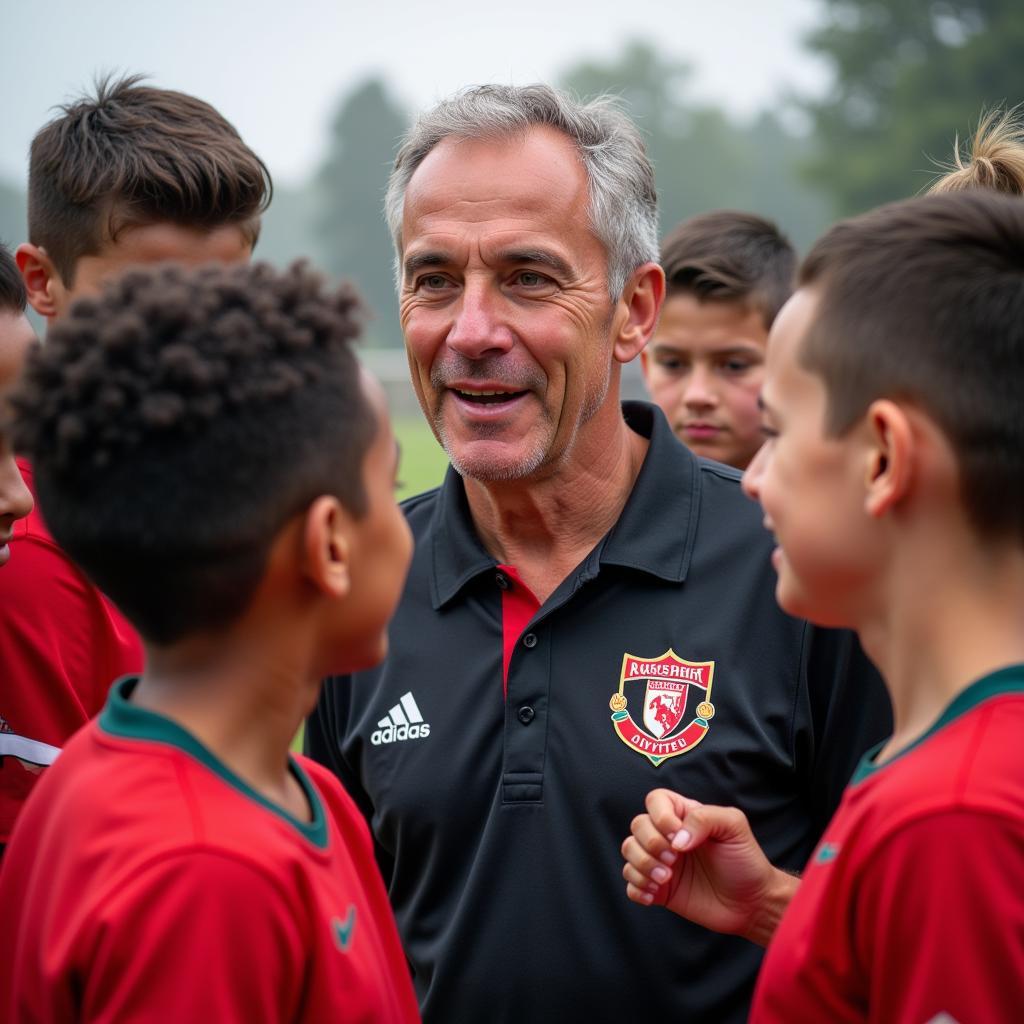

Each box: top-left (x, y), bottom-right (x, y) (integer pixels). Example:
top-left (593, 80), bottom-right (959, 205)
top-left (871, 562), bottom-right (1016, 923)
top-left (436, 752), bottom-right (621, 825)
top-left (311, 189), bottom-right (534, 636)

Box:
top-left (399, 127), bottom-right (617, 480)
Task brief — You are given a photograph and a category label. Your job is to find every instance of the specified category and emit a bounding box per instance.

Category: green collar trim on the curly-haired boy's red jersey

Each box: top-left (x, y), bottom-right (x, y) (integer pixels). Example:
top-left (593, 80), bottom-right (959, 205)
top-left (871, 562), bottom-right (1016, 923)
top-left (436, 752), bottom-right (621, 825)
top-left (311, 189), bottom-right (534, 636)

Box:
top-left (98, 676), bottom-right (328, 850)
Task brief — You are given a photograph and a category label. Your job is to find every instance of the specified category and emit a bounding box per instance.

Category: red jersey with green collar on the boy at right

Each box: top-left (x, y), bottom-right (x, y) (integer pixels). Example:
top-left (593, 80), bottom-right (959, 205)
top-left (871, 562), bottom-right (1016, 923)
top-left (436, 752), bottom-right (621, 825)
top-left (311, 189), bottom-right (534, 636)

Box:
top-left (751, 666), bottom-right (1024, 1024)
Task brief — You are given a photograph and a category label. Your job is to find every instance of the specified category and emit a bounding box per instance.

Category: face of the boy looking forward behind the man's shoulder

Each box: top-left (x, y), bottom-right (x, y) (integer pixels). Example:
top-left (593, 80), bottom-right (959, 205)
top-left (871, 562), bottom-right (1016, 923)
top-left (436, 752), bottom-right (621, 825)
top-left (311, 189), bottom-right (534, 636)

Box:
top-left (641, 293), bottom-right (768, 469)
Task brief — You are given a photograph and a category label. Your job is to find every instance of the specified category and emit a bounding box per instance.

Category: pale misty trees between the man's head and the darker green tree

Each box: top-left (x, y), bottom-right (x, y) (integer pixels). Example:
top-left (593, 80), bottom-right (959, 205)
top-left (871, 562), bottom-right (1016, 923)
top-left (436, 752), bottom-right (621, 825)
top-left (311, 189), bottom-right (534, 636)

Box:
top-left (560, 40), bottom-right (828, 248)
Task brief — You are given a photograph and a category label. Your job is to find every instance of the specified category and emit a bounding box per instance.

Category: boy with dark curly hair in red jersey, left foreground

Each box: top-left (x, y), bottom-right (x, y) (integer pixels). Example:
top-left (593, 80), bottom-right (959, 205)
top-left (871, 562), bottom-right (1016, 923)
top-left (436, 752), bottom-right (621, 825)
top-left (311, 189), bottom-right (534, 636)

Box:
top-left (0, 265), bottom-right (418, 1024)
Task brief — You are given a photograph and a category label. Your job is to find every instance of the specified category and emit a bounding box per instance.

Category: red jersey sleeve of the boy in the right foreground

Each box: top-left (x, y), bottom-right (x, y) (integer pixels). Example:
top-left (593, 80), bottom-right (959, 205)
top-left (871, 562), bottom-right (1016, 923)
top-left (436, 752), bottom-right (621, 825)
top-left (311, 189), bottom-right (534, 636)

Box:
top-left (854, 810), bottom-right (1024, 1024)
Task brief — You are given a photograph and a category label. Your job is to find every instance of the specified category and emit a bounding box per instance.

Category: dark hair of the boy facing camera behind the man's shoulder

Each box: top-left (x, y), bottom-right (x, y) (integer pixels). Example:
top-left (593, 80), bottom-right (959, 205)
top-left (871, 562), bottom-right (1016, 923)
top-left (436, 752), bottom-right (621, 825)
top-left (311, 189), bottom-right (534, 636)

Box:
top-left (662, 210), bottom-right (797, 327)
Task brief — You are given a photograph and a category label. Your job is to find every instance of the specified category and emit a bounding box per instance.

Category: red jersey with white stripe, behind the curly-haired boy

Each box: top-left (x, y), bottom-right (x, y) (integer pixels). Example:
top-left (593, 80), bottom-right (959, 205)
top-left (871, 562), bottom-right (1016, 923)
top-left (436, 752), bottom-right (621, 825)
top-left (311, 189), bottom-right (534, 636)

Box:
top-left (0, 459), bottom-right (142, 847)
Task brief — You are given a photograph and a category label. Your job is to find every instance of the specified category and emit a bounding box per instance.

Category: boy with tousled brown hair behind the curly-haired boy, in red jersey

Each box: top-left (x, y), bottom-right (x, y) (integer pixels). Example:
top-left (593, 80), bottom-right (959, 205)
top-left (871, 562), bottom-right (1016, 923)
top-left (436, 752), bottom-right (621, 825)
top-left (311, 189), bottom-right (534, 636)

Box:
top-left (0, 76), bottom-right (271, 853)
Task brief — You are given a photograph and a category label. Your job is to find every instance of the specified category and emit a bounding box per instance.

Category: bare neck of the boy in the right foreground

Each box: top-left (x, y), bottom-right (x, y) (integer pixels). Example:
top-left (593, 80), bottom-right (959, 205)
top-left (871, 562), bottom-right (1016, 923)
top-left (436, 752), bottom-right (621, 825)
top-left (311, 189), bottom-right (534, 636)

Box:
top-left (858, 535), bottom-right (1024, 761)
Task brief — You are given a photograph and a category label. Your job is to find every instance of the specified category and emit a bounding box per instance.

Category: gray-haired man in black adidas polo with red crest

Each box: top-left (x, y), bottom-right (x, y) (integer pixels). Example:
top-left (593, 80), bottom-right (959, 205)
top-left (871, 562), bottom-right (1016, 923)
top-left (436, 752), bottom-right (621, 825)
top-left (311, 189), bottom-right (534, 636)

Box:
top-left (306, 86), bottom-right (888, 1024)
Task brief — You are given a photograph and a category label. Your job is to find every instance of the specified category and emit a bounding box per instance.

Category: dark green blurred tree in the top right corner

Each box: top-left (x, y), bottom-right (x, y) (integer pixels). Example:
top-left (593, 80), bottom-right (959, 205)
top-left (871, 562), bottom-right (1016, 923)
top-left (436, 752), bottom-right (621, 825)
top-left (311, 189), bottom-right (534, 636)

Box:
top-left (805, 0), bottom-right (1024, 214)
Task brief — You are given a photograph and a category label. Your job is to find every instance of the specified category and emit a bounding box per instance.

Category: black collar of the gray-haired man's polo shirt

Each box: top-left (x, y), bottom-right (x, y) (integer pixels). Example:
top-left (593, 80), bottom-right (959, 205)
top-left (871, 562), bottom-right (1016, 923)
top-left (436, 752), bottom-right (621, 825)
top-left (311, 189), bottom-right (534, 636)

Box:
top-left (431, 401), bottom-right (700, 610)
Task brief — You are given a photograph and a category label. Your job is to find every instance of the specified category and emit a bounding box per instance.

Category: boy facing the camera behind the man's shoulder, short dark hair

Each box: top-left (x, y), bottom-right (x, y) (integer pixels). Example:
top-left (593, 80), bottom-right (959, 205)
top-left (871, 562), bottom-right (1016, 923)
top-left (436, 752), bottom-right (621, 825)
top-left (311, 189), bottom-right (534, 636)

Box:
top-left (640, 210), bottom-right (797, 469)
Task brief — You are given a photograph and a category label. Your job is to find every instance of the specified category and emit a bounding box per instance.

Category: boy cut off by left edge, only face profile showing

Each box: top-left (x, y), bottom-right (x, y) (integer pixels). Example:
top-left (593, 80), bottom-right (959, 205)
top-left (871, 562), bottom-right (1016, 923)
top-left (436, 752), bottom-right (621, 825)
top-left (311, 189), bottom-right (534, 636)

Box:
top-left (0, 245), bottom-right (36, 573)
